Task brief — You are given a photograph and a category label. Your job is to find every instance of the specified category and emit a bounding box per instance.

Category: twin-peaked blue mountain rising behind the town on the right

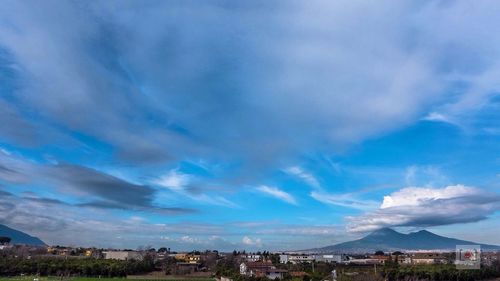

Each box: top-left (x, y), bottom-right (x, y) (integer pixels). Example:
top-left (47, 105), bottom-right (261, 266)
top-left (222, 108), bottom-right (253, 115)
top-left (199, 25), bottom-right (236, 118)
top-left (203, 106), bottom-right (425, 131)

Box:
top-left (309, 228), bottom-right (500, 253)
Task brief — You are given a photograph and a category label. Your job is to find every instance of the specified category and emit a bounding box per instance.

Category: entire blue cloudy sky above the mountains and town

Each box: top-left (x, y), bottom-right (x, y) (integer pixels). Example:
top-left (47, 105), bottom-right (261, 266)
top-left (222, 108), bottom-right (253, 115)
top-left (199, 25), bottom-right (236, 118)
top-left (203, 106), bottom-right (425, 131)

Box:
top-left (0, 0), bottom-right (500, 251)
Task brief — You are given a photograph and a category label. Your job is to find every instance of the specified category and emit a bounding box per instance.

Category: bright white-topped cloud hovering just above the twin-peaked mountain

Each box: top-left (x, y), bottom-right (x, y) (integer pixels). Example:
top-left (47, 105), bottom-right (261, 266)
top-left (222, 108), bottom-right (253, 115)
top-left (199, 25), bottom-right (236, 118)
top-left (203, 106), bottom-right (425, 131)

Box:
top-left (348, 185), bottom-right (500, 232)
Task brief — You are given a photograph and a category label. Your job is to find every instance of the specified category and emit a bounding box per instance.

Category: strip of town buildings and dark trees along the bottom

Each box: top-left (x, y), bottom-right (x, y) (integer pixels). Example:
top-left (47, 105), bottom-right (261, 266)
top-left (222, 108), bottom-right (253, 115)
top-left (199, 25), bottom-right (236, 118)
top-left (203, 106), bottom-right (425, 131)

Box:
top-left (0, 237), bottom-right (500, 281)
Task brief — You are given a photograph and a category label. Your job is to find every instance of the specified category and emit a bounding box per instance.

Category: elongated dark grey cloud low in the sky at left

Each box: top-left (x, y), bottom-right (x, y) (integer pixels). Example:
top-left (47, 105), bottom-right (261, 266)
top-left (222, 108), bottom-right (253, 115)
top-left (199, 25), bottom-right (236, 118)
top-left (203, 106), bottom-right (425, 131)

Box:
top-left (0, 151), bottom-right (194, 215)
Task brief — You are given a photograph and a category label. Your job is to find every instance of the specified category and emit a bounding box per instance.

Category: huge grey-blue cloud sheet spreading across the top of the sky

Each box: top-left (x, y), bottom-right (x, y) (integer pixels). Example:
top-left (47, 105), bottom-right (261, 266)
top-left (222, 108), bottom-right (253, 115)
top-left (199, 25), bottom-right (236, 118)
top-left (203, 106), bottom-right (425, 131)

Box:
top-left (0, 1), bottom-right (500, 173)
